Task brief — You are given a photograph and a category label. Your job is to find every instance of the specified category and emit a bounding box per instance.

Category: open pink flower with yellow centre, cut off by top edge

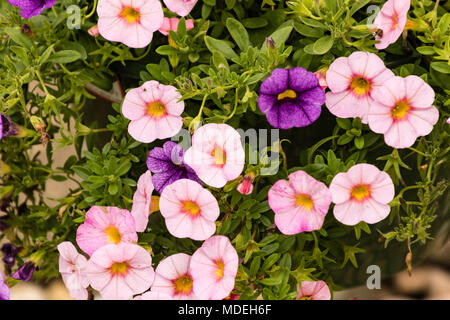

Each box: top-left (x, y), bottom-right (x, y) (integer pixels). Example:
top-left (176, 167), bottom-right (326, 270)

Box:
top-left (97, 0), bottom-right (164, 48)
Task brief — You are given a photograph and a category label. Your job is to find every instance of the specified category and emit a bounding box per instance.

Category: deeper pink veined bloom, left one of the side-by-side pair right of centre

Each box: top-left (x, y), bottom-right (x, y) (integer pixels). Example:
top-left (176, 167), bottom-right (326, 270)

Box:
top-left (268, 170), bottom-right (331, 234)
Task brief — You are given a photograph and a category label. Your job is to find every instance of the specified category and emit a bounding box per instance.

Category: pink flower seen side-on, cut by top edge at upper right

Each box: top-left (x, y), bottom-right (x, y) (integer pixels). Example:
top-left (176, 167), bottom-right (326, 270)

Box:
top-left (374, 0), bottom-right (411, 50)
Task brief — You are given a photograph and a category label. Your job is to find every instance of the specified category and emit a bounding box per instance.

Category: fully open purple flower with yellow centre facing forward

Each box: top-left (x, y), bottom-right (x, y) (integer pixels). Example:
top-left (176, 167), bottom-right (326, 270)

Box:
top-left (258, 67), bottom-right (325, 129)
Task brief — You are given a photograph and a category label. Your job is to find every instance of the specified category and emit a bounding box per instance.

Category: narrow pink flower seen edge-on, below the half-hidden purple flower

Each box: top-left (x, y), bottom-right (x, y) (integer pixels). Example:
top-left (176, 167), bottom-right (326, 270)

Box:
top-left (131, 170), bottom-right (154, 232)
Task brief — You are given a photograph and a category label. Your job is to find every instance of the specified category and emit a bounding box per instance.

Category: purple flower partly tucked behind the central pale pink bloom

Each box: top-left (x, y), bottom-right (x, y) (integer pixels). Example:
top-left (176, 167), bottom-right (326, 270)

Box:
top-left (147, 141), bottom-right (201, 194)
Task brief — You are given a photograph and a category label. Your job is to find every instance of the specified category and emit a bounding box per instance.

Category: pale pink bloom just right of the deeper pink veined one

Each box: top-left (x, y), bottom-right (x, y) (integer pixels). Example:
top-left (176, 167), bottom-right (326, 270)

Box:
top-left (330, 163), bottom-right (395, 226)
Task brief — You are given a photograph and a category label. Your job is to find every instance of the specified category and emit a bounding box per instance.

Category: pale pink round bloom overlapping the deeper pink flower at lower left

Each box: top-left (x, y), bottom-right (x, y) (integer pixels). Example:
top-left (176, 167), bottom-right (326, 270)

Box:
top-left (85, 243), bottom-right (155, 300)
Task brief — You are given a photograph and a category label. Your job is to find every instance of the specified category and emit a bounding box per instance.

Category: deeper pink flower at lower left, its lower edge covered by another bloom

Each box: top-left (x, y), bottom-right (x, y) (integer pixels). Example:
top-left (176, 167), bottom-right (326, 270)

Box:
top-left (77, 206), bottom-right (138, 255)
